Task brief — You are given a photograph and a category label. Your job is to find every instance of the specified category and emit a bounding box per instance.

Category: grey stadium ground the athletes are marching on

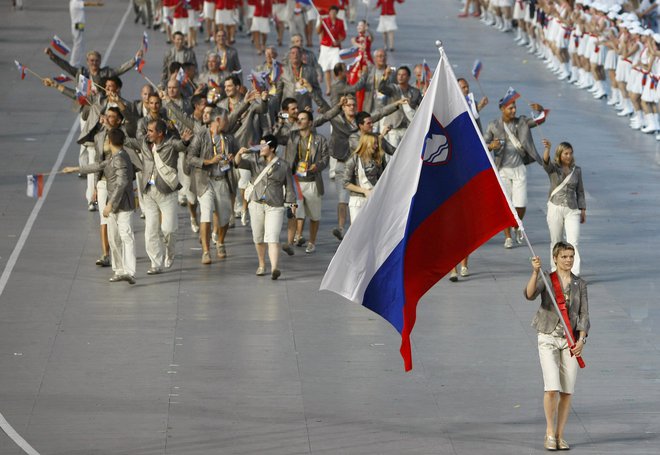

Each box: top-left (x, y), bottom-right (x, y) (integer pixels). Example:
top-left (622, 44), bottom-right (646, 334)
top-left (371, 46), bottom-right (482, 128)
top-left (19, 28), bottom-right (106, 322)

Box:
top-left (0, 0), bottom-right (660, 455)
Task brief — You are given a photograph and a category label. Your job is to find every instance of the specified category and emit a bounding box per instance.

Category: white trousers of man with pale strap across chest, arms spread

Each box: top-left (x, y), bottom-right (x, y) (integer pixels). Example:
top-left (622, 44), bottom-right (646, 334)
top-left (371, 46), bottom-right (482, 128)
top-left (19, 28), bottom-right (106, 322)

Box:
top-left (142, 185), bottom-right (179, 268)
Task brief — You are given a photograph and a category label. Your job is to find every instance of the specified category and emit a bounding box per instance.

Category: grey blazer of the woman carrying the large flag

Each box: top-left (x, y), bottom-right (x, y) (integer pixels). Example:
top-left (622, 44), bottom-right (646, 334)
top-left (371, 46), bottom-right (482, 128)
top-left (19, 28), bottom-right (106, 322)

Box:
top-left (523, 272), bottom-right (591, 333)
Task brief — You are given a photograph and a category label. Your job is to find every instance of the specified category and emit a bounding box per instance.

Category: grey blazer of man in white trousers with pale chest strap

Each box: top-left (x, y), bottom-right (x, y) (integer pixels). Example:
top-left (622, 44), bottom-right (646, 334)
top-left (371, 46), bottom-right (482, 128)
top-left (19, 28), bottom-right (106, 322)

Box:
top-left (124, 134), bottom-right (187, 194)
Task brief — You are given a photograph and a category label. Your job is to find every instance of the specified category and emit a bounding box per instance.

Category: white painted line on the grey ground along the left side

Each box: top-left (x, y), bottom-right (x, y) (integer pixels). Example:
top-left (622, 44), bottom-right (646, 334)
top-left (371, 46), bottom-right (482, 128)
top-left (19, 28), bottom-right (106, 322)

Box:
top-left (0, 2), bottom-right (132, 455)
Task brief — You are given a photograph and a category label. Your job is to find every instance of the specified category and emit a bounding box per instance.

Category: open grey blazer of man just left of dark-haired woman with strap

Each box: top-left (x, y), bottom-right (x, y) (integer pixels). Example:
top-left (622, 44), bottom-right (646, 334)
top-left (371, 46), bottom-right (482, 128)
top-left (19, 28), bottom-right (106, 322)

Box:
top-left (186, 129), bottom-right (238, 197)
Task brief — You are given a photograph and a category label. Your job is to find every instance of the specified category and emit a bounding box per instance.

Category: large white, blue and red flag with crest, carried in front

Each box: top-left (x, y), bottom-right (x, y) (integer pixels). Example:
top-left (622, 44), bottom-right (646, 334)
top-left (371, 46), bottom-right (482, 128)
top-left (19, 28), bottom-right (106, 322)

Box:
top-left (321, 50), bottom-right (517, 371)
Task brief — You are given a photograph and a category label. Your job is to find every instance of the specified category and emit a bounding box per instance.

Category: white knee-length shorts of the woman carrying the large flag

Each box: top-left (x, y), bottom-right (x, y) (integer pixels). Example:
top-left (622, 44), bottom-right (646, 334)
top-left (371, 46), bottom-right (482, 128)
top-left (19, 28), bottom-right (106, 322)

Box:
top-left (538, 333), bottom-right (578, 394)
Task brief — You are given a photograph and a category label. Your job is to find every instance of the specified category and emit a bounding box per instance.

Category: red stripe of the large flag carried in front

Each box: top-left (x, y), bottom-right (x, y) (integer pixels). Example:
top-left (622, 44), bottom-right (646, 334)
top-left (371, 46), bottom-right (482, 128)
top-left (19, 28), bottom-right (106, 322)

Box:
top-left (401, 169), bottom-right (516, 371)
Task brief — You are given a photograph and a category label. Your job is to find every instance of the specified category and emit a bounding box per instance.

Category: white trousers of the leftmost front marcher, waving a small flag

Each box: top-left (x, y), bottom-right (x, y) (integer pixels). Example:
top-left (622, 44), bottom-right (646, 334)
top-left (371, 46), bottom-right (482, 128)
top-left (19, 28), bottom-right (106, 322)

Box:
top-left (107, 209), bottom-right (136, 276)
